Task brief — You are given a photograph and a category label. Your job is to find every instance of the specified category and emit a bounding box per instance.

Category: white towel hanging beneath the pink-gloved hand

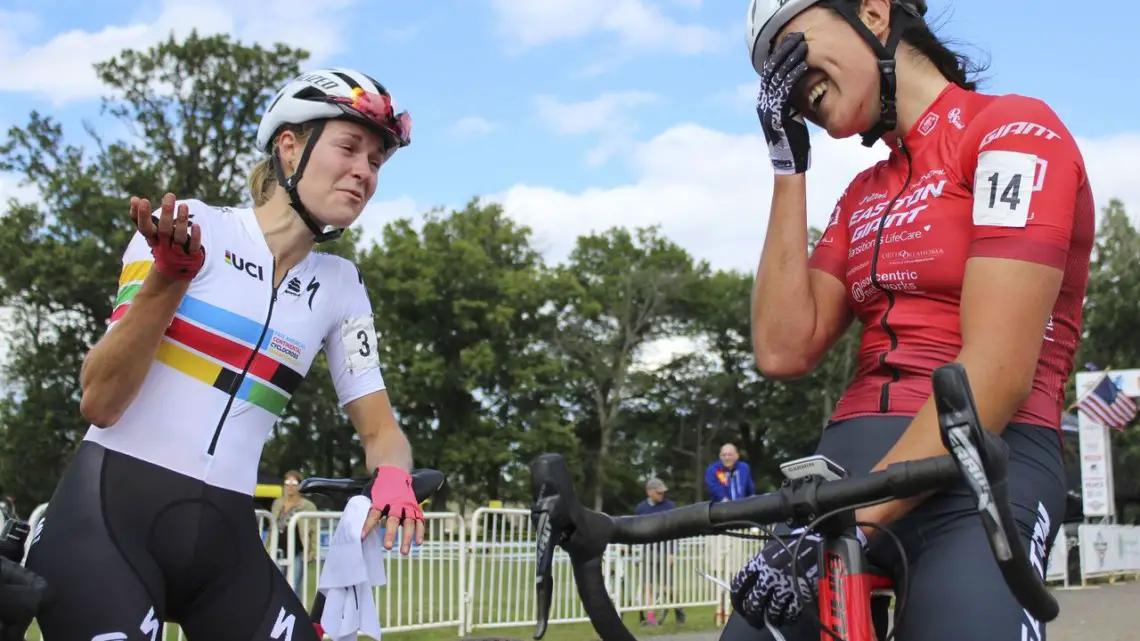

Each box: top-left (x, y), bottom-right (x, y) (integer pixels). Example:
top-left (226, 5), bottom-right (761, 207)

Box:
top-left (317, 496), bottom-right (388, 641)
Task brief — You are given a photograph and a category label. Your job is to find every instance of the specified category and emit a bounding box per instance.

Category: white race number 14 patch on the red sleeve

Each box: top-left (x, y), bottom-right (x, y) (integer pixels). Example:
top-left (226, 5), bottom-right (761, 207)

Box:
top-left (974, 151), bottom-right (1044, 227)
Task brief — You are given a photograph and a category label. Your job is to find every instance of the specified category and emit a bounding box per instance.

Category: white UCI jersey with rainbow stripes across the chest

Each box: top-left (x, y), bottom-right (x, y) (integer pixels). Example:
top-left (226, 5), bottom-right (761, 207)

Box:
top-left (84, 200), bottom-right (384, 495)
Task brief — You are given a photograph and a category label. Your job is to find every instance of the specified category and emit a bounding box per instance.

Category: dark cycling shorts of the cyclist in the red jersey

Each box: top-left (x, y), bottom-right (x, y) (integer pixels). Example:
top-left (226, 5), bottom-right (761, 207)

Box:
top-left (720, 416), bottom-right (1065, 641)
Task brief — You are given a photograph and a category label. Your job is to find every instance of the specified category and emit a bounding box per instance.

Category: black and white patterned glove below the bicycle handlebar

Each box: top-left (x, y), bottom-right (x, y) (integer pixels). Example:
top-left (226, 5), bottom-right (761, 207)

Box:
top-left (731, 528), bottom-right (866, 630)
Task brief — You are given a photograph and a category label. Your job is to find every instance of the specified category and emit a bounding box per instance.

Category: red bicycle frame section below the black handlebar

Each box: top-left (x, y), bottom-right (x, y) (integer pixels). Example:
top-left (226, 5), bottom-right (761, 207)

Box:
top-left (819, 535), bottom-right (894, 641)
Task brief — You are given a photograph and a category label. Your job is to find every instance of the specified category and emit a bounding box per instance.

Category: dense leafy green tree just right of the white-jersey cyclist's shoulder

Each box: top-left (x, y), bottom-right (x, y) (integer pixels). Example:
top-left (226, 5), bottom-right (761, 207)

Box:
top-left (360, 202), bottom-right (575, 502)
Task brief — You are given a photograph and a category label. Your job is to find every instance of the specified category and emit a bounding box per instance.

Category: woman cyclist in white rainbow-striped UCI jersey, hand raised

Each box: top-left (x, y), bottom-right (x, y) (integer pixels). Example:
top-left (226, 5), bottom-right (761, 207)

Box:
top-left (27, 68), bottom-right (424, 641)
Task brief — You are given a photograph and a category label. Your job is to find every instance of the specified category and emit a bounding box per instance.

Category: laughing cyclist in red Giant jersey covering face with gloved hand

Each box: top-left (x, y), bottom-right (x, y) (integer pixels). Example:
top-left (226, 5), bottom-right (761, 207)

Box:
top-left (722, 0), bottom-right (1094, 641)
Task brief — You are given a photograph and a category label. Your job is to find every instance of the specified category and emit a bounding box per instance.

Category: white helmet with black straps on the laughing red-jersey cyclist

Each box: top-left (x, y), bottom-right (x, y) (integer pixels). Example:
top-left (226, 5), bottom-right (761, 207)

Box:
top-left (747, 0), bottom-right (926, 147)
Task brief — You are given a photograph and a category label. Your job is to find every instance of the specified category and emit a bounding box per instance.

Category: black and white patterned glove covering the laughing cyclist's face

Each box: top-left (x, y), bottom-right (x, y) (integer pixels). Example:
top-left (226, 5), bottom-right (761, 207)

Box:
top-left (756, 33), bottom-right (812, 175)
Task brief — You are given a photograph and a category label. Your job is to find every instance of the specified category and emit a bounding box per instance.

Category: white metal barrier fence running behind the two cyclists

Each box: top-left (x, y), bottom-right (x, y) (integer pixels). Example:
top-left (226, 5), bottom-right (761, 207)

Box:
top-left (17, 504), bottom-right (1140, 641)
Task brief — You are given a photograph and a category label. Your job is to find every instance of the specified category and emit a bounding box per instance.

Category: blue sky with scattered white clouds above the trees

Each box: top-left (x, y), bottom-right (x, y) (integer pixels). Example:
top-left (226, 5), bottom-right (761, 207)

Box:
top-left (0, 0), bottom-right (1140, 269)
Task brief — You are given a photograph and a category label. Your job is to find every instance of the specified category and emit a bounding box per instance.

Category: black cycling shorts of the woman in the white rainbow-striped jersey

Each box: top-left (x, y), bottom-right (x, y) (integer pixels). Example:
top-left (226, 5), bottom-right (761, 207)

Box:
top-left (27, 441), bottom-right (318, 641)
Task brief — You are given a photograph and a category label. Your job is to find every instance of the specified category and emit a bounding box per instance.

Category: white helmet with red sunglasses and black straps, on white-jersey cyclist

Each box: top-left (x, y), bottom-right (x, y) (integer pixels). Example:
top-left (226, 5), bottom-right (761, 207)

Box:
top-left (257, 67), bottom-right (412, 243)
